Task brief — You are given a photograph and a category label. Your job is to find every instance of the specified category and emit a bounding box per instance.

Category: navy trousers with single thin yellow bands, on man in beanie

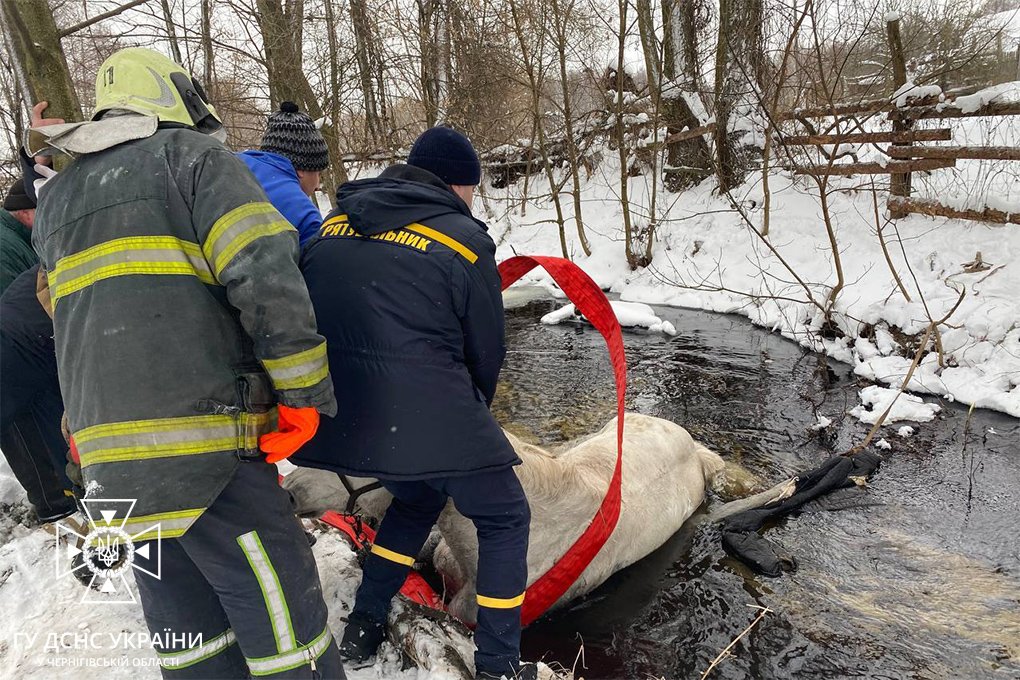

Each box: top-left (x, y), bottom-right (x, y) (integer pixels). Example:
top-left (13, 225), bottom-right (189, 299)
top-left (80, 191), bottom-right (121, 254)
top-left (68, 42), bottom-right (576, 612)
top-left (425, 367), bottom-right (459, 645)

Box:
top-left (354, 468), bottom-right (531, 677)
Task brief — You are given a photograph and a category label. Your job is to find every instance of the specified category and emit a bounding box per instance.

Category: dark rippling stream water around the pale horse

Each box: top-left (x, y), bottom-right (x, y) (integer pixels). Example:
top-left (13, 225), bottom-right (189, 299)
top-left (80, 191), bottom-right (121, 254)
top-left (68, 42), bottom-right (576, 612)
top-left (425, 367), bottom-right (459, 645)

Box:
top-left (496, 295), bottom-right (1020, 680)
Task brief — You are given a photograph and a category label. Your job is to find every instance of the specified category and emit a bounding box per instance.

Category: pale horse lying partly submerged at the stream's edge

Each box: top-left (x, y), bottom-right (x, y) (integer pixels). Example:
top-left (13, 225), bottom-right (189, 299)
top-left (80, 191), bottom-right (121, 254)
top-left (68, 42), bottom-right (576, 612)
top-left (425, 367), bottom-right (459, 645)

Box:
top-left (284, 413), bottom-right (794, 623)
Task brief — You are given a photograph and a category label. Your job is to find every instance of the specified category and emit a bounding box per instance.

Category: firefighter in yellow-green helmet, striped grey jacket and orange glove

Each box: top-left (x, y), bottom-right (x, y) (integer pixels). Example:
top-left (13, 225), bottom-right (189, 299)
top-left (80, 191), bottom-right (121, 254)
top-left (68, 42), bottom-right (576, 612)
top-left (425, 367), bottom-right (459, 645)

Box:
top-left (33, 48), bottom-right (344, 678)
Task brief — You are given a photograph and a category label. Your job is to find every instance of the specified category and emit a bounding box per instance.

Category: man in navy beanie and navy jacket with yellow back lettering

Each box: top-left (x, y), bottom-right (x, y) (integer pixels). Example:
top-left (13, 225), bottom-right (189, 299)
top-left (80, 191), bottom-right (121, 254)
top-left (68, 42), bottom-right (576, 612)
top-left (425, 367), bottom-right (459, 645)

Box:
top-left (292, 127), bottom-right (537, 678)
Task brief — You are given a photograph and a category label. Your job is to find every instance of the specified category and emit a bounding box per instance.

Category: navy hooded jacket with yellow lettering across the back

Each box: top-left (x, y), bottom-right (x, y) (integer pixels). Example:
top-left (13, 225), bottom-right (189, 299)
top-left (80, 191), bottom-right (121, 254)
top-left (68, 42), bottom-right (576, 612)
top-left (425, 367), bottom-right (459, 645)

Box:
top-left (292, 165), bottom-right (520, 480)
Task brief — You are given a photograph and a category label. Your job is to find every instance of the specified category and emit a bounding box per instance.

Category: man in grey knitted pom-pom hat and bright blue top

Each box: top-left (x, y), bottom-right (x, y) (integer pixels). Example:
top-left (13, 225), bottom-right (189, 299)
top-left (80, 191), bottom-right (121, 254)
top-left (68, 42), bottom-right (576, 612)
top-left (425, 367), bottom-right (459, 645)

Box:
top-left (240, 102), bottom-right (329, 246)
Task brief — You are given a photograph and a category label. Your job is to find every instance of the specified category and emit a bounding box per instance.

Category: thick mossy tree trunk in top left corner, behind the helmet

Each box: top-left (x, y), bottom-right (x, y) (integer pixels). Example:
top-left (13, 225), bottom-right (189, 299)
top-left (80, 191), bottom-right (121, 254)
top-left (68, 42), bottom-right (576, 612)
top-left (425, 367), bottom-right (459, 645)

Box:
top-left (0, 0), bottom-right (82, 122)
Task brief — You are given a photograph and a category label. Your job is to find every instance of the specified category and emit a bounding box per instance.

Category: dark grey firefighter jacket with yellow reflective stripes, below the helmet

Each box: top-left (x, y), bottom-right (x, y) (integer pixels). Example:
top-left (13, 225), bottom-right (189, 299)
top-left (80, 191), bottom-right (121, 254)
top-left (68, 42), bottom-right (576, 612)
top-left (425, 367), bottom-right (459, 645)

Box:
top-left (33, 127), bottom-right (336, 539)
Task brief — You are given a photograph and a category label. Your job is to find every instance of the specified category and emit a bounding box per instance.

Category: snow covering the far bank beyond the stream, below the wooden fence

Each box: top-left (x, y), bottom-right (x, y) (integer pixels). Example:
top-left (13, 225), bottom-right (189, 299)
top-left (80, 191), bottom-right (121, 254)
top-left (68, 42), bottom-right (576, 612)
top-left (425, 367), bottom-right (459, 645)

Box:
top-left (474, 118), bottom-right (1020, 417)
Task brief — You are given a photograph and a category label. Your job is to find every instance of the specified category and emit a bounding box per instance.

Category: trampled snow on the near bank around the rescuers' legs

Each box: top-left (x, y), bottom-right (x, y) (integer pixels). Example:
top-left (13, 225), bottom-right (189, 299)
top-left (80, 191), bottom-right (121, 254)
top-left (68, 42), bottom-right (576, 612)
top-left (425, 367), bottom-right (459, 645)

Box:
top-left (0, 459), bottom-right (442, 680)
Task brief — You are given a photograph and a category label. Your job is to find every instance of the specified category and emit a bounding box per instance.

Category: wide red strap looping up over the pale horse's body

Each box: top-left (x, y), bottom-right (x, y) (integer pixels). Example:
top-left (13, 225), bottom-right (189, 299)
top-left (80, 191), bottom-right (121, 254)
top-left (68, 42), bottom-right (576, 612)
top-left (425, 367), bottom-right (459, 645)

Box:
top-left (499, 256), bottom-right (627, 626)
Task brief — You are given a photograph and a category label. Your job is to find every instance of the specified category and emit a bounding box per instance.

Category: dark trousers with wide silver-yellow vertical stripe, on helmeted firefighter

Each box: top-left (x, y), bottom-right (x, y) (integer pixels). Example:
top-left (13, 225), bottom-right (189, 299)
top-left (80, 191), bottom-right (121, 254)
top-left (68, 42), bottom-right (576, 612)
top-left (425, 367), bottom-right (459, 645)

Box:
top-left (136, 460), bottom-right (345, 680)
